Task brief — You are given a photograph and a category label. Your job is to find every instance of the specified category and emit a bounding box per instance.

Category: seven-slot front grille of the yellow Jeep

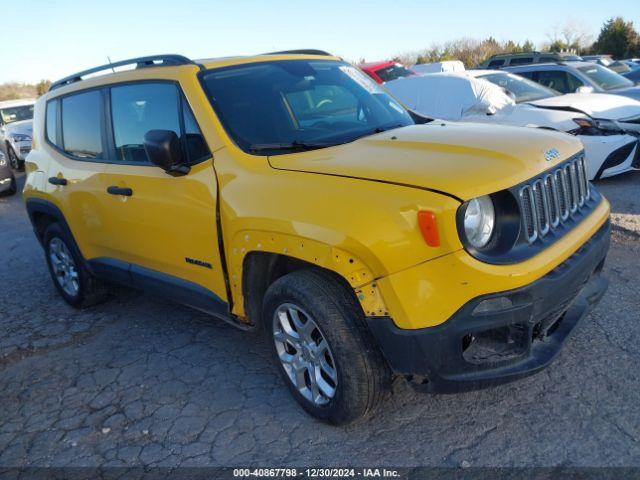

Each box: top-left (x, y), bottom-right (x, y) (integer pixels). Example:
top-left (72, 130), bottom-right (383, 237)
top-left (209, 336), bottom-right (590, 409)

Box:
top-left (518, 155), bottom-right (591, 243)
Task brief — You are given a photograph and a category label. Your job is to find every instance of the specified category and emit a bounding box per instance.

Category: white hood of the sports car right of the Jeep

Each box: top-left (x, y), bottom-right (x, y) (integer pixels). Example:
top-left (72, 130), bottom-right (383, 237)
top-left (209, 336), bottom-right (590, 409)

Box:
top-left (529, 93), bottom-right (640, 120)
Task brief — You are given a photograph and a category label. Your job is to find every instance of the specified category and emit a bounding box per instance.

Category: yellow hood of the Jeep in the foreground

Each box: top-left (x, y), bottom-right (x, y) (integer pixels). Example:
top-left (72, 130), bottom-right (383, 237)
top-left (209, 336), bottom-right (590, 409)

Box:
top-left (269, 121), bottom-right (582, 200)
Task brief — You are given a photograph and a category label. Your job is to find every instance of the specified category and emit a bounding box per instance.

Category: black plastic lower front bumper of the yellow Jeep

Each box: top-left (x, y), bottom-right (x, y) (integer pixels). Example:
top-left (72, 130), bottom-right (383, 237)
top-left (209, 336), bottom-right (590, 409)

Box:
top-left (367, 221), bottom-right (611, 393)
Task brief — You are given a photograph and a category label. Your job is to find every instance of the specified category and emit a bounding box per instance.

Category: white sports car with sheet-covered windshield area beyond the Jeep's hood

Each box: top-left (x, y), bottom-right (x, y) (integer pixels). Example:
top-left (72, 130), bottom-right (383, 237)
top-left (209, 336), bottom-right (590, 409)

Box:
top-left (384, 70), bottom-right (640, 180)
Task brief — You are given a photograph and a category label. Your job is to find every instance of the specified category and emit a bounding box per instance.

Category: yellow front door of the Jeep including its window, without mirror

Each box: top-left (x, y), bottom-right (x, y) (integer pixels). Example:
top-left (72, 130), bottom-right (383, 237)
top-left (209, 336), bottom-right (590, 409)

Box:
top-left (99, 81), bottom-right (227, 306)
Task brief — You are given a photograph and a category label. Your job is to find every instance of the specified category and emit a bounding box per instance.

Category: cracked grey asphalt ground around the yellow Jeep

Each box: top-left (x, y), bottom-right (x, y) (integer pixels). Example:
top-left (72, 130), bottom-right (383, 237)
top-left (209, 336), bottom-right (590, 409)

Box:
top-left (0, 172), bottom-right (640, 467)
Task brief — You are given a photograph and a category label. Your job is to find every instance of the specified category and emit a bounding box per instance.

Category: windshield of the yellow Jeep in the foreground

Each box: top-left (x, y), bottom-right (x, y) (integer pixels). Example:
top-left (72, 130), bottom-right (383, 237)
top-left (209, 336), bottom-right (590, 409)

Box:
top-left (202, 60), bottom-right (414, 155)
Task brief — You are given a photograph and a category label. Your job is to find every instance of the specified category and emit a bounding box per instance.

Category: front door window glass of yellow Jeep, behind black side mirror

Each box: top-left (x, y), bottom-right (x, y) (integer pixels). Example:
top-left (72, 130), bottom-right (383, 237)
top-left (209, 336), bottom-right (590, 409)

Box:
top-left (111, 83), bottom-right (180, 163)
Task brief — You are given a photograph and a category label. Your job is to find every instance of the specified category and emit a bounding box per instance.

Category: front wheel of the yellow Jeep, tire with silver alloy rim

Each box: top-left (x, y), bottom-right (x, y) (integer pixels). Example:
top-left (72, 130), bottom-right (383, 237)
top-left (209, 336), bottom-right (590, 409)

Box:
top-left (263, 270), bottom-right (391, 425)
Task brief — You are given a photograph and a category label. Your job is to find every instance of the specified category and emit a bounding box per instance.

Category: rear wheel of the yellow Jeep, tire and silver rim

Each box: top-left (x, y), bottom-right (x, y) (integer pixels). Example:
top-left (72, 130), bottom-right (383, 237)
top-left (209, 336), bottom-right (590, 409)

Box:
top-left (43, 222), bottom-right (108, 308)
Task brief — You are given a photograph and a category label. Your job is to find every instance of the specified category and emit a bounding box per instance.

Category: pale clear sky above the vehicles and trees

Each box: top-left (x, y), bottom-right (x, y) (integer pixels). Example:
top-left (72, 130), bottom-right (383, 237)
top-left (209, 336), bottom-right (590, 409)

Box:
top-left (0, 0), bottom-right (640, 82)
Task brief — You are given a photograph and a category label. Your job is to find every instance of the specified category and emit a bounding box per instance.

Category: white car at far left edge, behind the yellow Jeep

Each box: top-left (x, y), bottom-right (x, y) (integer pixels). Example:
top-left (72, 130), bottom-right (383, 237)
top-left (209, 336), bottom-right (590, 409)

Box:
top-left (0, 99), bottom-right (35, 170)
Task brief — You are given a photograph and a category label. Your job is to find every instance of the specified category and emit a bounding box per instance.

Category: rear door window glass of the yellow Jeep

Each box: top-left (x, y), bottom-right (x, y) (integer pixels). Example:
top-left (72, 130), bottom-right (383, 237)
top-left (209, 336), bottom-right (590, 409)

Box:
top-left (62, 90), bottom-right (102, 159)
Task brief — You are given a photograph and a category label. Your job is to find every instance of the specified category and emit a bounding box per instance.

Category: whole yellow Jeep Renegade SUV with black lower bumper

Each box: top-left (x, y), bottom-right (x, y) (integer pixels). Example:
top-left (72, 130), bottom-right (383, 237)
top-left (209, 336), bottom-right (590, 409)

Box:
top-left (24, 51), bottom-right (610, 423)
